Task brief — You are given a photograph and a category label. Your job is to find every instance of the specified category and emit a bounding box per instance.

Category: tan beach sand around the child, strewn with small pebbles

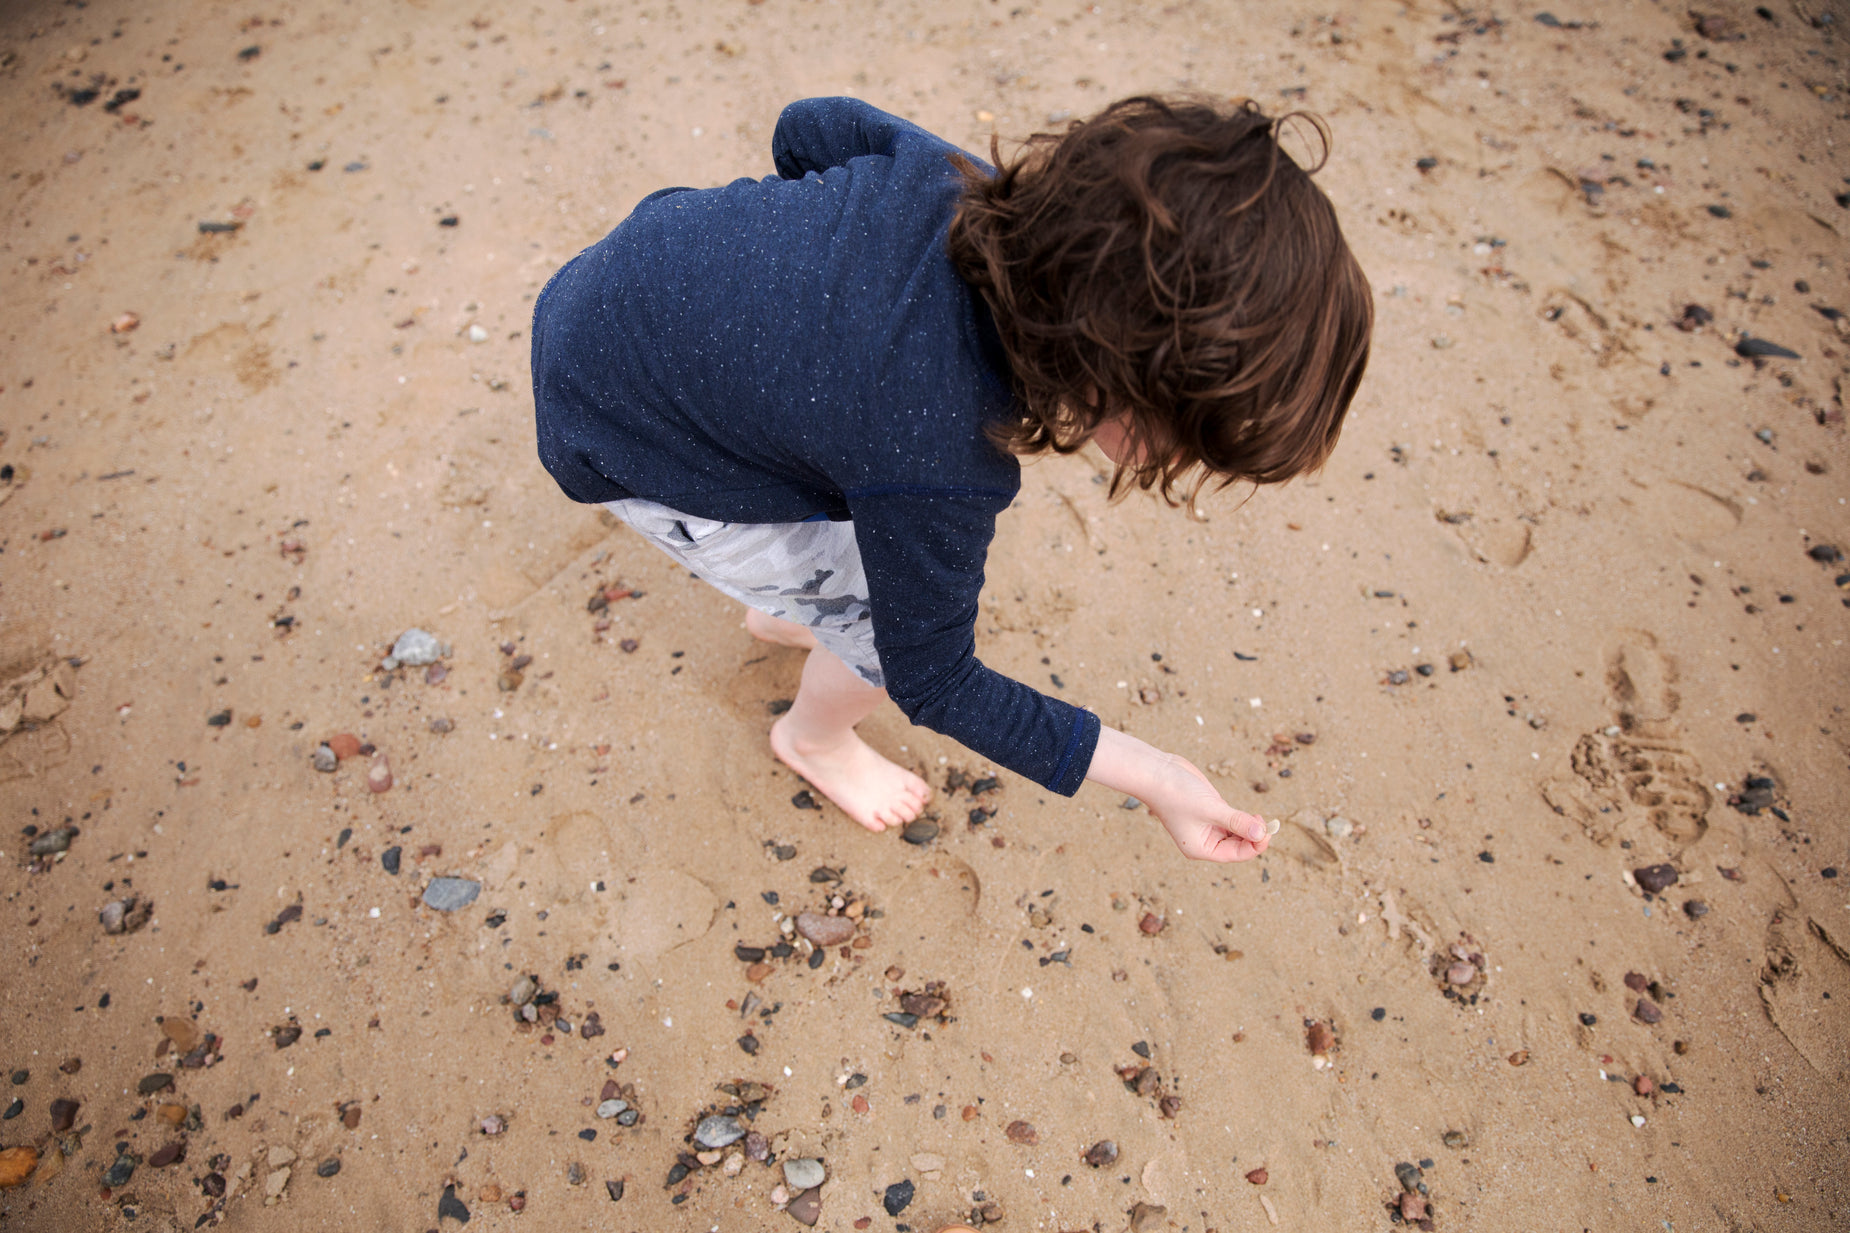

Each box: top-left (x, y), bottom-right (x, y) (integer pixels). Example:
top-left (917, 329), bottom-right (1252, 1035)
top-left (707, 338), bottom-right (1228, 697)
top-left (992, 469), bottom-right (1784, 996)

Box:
top-left (0, 0), bottom-right (1850, 1233)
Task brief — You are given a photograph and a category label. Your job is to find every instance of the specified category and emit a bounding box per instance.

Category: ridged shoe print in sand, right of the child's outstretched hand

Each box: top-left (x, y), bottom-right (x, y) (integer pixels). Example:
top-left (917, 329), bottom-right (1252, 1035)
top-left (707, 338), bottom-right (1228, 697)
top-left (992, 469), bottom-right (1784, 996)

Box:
top-left (1541, 631), bottom-right (1713, 844)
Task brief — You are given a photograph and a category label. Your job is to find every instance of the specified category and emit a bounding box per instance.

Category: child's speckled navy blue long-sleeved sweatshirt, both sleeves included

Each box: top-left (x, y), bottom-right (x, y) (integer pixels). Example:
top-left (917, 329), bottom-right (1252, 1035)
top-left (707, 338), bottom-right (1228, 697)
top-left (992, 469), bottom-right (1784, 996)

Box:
top-left (533, 98), bottom-right (1099, 796)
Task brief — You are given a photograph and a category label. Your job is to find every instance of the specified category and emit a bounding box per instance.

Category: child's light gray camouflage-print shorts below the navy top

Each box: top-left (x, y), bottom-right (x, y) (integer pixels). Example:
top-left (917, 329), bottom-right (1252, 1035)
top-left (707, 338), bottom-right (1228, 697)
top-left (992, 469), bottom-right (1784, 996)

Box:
top-left (605, 498), bottom-right (886, 689)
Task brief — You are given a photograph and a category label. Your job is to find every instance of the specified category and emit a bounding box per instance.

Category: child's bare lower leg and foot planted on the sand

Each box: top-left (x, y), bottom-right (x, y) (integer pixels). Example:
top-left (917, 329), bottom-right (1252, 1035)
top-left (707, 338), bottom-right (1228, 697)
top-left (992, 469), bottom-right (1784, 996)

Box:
top-left (771, 636), bottom-right (931, 831)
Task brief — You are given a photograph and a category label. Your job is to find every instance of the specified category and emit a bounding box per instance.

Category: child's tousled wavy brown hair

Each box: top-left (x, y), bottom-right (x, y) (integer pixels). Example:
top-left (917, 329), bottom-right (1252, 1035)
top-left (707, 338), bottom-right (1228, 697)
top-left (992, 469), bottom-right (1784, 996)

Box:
top-left (949, 96), bottom-right (1375, 505)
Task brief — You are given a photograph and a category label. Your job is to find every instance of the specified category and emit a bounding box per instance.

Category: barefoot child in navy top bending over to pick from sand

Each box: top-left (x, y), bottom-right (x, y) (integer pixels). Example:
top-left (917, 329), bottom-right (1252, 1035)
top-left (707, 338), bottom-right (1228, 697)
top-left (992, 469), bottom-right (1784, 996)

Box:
top-left (533, 98), bottom-right (1373, 861)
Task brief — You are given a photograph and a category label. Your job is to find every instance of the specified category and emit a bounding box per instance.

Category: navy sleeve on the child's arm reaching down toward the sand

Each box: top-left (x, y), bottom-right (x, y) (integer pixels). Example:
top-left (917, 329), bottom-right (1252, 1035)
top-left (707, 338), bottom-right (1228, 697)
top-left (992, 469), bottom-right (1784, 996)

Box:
top-left (847, 487), bottom-right (1099, 796)
